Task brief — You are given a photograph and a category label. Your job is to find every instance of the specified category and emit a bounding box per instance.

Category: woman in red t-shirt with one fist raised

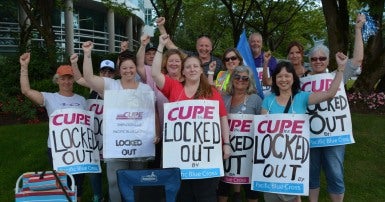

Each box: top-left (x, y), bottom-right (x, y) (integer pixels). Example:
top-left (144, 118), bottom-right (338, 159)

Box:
top-left (151, 34), bottom-right (230, 201)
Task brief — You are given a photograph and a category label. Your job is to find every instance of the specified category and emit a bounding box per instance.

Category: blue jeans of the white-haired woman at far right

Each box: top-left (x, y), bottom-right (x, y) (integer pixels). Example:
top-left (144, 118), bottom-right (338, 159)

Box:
top-left (309, 145), bottom-right (345, 194)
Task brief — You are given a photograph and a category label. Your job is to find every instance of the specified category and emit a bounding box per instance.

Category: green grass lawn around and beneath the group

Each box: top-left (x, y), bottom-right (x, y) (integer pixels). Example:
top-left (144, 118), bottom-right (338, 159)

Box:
top-left (0, 114), bottom-right (385, 202)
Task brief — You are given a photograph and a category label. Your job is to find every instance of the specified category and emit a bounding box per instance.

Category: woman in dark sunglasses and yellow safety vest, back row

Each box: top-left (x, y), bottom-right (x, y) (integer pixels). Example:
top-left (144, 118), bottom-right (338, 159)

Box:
top-left (208, 48), bottom-right (243, 91)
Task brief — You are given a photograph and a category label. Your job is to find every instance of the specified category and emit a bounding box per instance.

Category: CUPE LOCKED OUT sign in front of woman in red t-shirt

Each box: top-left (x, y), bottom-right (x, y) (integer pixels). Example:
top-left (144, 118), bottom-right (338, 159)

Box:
top-left (163, 100), bottom-right (223, 179)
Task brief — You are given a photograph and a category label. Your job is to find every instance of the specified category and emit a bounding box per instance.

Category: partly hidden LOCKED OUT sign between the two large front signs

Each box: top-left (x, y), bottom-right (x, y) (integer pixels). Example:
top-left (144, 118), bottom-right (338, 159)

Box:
top-left (222, 114), bottom-right (254, 184)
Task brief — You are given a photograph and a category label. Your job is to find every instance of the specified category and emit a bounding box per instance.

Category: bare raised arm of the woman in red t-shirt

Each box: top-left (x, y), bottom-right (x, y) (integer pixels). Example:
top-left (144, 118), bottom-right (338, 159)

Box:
top-left (151, 34), bottom-right (168, 89)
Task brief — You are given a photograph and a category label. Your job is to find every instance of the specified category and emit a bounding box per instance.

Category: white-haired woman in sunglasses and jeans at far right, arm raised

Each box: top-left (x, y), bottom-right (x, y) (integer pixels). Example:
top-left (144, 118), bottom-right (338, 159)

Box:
top-left (309, 14), bottom-right (366, 202)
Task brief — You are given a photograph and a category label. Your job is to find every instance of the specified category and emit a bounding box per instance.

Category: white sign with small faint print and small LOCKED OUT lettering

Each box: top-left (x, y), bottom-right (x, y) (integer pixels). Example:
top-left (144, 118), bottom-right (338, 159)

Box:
top-left (103, 89), bottom-right (155, 159)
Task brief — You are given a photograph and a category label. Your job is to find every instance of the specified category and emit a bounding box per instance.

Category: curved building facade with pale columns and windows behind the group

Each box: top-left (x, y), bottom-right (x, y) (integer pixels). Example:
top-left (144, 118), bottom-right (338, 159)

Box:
top-left (0, 0), bottom-right (153, 54)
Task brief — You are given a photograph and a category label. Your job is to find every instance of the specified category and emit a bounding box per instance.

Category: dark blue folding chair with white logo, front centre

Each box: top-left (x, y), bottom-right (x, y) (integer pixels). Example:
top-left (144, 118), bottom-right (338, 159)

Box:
top-left (116, 168), bottom-right (181, 202)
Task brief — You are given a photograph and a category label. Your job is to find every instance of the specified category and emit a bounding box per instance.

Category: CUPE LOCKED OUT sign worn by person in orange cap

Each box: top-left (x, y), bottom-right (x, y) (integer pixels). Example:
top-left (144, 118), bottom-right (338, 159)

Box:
top-left (49, 108), bottom-right (101, 174)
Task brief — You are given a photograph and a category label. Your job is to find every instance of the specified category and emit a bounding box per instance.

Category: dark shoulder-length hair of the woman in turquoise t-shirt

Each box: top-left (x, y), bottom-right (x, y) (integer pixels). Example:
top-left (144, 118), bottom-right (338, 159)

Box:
top-left (271, 61), bottom-right (301, 96)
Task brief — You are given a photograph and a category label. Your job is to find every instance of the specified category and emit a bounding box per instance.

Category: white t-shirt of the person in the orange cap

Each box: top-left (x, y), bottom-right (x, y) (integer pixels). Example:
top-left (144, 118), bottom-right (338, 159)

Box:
top-left (42, 92), bottom-right (86, 148)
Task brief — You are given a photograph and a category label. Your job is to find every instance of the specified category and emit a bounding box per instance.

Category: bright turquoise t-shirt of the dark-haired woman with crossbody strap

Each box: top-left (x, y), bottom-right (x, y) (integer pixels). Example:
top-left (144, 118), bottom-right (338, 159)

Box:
top-left (262, 91), bottom-right (311, 114)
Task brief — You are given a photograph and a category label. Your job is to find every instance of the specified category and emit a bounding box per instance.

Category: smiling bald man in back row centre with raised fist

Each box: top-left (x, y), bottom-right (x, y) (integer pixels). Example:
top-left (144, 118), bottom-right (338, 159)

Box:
top-left (156, 17), bottom-right (223, 79)
